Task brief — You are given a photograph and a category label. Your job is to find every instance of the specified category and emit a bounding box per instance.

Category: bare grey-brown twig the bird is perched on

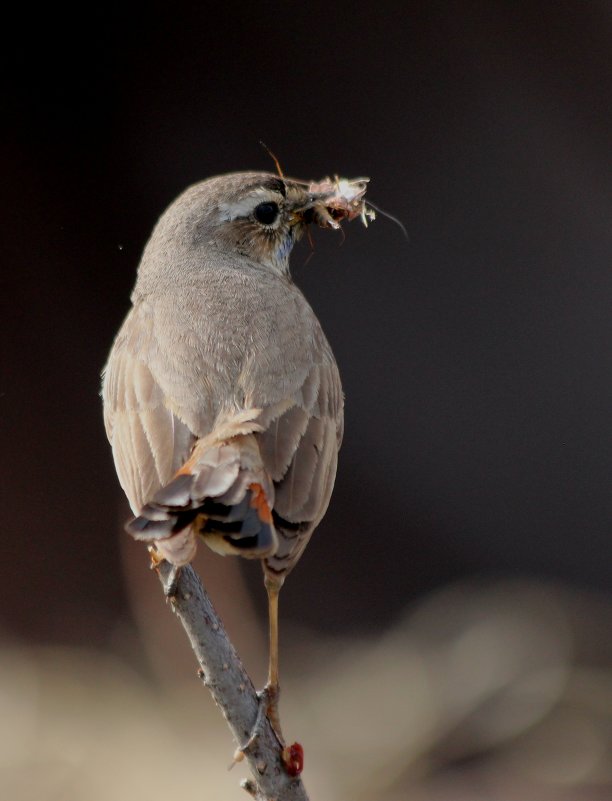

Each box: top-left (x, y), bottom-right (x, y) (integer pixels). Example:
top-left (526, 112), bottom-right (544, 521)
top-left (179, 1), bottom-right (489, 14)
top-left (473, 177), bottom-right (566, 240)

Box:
top-left (158, 562), bottom-right (308, 801)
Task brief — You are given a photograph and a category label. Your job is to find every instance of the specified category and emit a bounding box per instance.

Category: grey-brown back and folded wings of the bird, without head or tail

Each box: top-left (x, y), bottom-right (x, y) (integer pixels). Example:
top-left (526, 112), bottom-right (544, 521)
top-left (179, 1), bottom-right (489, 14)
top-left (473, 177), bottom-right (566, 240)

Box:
top-left (104, 259), bottom-right (343, 574)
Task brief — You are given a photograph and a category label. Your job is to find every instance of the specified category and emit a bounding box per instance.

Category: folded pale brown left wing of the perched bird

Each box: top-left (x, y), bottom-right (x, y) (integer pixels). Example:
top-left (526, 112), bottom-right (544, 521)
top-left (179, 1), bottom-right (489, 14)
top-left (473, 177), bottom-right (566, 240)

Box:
top-left (102, 306), bottom-right (195, 513)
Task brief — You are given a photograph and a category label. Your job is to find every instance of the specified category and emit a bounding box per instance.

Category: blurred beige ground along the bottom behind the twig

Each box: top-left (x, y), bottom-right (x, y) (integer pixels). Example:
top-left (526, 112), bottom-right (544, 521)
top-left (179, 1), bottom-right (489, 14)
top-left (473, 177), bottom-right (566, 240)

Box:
top-left (0, 581), bottom-right (612, 801)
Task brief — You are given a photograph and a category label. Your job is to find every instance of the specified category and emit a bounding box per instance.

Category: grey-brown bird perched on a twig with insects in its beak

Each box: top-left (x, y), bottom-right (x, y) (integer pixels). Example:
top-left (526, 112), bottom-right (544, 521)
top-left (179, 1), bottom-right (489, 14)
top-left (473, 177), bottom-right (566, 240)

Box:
top-left (102, 172), bottom-right (373, 735)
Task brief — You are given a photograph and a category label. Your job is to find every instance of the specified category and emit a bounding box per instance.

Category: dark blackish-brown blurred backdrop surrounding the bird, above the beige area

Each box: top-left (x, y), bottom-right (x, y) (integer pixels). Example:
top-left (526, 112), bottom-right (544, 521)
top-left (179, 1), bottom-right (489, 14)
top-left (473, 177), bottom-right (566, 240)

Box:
top-left (0, 0), bottom-right (612, 801)
